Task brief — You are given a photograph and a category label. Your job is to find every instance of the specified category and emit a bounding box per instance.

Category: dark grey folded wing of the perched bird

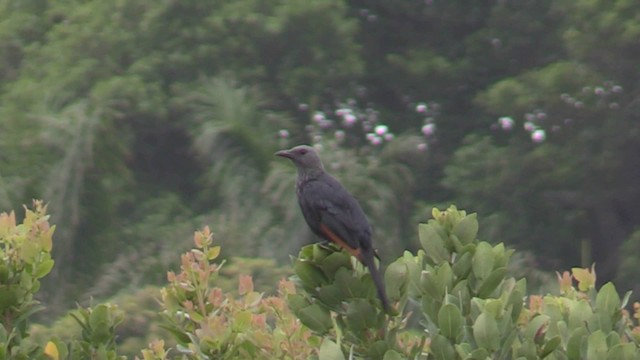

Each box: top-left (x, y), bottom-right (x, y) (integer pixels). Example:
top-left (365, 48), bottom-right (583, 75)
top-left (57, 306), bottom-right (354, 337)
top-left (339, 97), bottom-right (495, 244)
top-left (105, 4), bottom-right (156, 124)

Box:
top-left (303, 174), bottom-right (371, 253)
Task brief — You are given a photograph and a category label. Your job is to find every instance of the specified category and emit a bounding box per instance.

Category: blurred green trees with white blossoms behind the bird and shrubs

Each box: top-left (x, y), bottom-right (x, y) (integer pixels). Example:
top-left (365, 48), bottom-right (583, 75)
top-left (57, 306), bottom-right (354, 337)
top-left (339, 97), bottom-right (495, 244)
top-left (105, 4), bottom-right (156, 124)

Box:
top-left (0, 0), bottom-right (640, 316)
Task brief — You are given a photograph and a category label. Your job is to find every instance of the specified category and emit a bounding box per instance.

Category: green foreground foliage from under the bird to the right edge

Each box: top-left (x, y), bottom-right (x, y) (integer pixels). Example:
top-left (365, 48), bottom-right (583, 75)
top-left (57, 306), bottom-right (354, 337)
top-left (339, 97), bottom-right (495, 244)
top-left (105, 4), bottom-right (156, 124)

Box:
top-left (289, 206), bottom-right (640, 359)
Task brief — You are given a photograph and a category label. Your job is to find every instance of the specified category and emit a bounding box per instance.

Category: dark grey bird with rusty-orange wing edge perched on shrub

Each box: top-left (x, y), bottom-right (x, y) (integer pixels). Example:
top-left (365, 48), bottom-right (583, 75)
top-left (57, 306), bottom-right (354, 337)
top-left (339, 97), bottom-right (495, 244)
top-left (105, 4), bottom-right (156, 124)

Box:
top-left (275, 145), bottom-right (392, 313)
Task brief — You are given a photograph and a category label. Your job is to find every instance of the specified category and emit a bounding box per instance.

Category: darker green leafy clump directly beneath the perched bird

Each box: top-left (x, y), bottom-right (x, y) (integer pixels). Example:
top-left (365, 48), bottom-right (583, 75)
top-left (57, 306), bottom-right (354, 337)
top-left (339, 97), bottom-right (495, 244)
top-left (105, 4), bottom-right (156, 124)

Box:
top-left (287, 244), bottom-right (419, 359)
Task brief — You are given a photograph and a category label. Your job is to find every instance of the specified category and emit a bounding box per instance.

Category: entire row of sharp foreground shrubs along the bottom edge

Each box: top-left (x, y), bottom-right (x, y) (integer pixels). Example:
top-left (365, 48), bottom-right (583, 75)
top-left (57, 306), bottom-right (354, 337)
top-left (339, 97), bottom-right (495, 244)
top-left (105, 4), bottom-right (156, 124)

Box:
top-left (5, 201), bottom-right (640, 360)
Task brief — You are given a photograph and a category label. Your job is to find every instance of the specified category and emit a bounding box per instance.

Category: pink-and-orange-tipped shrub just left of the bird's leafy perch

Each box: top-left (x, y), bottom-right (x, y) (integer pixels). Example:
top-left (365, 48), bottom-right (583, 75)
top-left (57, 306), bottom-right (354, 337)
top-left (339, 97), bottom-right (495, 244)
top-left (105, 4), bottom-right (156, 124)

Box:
top-left (151, 228), bottom-right (319, 359)
